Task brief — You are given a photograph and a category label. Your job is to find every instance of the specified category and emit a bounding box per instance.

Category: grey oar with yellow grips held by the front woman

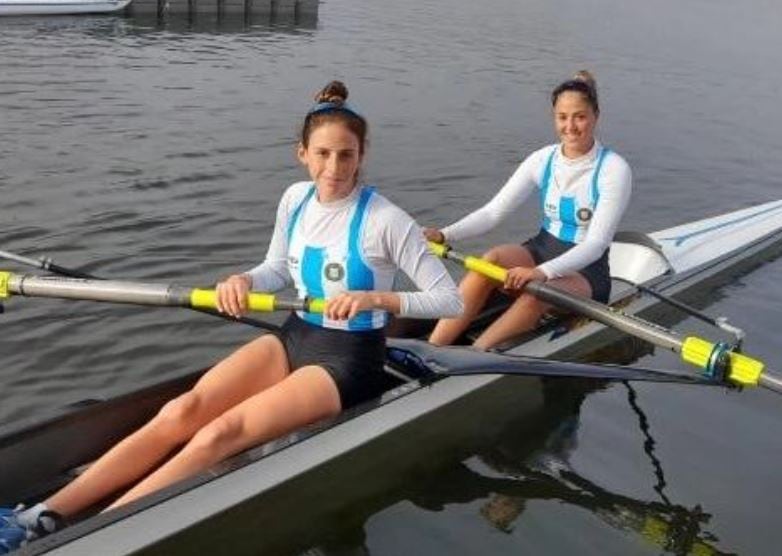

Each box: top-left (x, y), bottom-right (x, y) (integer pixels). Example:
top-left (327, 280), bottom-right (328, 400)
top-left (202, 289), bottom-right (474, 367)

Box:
top-left (0, 271), bottom-right (325, 313)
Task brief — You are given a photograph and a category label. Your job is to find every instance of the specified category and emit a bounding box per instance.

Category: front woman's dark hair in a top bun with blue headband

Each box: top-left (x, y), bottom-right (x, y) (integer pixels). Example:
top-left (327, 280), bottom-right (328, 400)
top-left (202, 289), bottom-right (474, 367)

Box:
top-left (300, 81), bottom-right (369, 154)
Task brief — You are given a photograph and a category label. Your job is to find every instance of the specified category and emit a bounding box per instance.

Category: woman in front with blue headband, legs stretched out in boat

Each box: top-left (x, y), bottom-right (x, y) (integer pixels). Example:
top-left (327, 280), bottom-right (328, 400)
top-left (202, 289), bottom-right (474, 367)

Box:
top-left (0, 81), bottom-right (462, 553)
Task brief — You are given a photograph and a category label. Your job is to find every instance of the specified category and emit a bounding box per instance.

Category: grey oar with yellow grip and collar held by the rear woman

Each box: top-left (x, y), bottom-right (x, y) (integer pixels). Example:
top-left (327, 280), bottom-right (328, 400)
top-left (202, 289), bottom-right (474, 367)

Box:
top-left (429, 242), bottom-right (782, 393)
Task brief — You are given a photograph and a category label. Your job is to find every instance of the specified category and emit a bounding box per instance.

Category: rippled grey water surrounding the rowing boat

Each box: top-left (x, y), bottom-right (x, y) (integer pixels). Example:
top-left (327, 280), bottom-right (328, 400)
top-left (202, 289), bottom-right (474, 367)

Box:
top-left (0, 0), bottom-right (782, 555)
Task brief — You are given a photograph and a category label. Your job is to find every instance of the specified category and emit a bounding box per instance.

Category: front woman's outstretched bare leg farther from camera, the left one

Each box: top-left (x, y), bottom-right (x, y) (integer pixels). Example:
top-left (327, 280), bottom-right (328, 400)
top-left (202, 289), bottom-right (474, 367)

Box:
top-left (46, 335), bottom-right (289, 516)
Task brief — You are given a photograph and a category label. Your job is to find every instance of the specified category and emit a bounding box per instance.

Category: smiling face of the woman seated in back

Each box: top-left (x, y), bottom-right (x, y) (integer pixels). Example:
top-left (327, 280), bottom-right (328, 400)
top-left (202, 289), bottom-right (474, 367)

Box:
top-left (554, 91), bottom-right (597, 158)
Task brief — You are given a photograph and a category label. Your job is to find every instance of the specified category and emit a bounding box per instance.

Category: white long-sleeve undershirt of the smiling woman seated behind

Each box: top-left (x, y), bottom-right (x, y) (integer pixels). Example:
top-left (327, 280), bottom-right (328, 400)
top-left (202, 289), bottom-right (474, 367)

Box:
top-left (442, 141), bottom-right (632, 278)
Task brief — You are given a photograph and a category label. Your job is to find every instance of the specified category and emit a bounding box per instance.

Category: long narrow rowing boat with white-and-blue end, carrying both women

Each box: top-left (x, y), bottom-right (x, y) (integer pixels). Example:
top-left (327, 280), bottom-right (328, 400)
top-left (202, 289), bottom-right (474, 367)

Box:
top-left (0, 201), bottom-right (782, 555)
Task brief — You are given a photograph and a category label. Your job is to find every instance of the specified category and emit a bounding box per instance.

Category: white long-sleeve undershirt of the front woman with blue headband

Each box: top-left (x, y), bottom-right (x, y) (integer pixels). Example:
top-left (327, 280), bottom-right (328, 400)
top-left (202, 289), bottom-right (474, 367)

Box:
top-left (248, 182), bottom-right (464, 318)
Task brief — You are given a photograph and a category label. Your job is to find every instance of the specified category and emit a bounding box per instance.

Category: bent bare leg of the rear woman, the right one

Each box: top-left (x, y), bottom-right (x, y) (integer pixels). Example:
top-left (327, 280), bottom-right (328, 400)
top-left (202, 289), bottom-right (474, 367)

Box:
top-left (474, 274), bottom-right (592, 350)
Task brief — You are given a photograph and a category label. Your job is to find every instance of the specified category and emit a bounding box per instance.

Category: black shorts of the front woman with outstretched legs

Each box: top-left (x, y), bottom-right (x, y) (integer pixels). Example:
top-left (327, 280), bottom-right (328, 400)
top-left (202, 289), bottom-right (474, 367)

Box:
top-left (279, 313), bottom-right (387, 409)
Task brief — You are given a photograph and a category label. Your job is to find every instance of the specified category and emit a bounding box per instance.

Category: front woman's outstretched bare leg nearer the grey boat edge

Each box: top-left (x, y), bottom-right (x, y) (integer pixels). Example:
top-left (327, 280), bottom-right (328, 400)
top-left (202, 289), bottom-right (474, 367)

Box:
top-left (111, 366), bottom-right (341, 508)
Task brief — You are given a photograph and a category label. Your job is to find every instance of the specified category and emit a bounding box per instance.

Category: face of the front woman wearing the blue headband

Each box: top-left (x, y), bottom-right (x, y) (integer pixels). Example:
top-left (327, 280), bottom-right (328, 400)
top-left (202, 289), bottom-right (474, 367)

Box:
top-left (298, 122), bottom-right (362, 202)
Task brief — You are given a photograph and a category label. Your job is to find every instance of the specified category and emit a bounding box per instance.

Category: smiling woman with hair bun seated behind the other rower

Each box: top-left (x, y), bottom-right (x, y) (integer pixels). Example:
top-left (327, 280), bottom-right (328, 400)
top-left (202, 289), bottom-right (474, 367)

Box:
top-left (424, 71), bottom-right (632, 349)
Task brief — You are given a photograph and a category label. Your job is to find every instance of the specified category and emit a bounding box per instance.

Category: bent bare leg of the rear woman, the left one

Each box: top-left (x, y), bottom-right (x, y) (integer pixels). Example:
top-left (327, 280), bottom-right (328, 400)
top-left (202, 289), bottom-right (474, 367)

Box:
top-left (429, 244), bottom-right (535, 346)
